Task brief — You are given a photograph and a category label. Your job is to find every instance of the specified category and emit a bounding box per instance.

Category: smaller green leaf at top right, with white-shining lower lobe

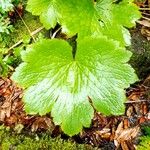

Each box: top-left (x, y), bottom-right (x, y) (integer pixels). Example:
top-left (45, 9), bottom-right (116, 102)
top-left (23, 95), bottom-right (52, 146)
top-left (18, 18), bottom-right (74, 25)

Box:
top-left (95, 0), bottom-right (141, 46)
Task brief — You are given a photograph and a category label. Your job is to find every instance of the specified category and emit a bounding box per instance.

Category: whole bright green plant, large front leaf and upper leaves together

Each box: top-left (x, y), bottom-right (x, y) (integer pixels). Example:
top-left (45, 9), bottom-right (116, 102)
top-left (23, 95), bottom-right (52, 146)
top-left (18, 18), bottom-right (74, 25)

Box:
top-left (12, 0), bottom-right (140, 136)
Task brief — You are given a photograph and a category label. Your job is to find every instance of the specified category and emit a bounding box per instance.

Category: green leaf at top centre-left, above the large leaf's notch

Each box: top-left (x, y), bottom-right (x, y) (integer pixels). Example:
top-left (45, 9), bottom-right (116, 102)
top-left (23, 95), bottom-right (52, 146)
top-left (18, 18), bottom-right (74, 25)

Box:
top-left (27, 0), bottom-right (100, 37)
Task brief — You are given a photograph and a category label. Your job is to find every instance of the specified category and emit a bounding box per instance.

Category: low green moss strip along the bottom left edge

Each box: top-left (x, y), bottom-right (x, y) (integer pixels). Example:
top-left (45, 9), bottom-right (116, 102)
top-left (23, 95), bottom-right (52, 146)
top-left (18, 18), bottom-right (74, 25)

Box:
top-left (0, 126), bottom-right (94, 150)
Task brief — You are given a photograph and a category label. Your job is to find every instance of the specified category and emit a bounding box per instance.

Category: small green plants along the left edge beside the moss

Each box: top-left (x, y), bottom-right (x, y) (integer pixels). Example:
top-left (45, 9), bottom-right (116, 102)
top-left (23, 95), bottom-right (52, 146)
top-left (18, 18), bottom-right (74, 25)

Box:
top-left (0, 0), bottom-right (20, 76)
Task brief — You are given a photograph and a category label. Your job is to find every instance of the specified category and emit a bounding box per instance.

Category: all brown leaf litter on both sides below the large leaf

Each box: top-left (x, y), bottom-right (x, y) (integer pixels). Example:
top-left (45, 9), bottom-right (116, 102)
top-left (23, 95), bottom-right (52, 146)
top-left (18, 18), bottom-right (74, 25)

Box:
top-left (0, 77), bottom-right (150, 150)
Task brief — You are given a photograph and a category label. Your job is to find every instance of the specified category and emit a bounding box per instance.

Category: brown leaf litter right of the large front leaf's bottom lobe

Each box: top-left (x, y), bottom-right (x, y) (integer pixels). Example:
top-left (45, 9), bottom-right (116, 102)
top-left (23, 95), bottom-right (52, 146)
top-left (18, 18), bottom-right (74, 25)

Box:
top-left (80, 78), bottom-right (150, 150)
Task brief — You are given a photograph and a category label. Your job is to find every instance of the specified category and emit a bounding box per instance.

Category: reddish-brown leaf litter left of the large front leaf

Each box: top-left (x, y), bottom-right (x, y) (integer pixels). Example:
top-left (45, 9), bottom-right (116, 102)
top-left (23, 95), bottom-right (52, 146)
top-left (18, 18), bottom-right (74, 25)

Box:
top-left (0, 78), bottom-right (54, 131)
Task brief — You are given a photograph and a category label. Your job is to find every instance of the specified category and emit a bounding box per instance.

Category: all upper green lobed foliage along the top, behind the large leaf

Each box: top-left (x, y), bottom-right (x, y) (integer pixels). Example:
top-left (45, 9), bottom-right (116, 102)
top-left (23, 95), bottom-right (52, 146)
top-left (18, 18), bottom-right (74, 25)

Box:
top-left (27, 0), bottom-right (141, 46)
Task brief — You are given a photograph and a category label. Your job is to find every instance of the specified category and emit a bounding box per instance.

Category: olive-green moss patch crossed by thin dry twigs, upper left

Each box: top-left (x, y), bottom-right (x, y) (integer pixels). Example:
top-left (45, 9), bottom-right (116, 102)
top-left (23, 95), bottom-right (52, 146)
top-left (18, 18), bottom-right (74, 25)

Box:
top-left (0, 11), bottom-right (46, 47)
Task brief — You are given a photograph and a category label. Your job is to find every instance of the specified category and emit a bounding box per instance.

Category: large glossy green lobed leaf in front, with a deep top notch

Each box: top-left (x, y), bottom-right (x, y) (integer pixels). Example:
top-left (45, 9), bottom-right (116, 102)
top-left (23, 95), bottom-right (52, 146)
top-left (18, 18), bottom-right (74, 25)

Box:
top-left (12, 37), bottom-right (137, 136)
